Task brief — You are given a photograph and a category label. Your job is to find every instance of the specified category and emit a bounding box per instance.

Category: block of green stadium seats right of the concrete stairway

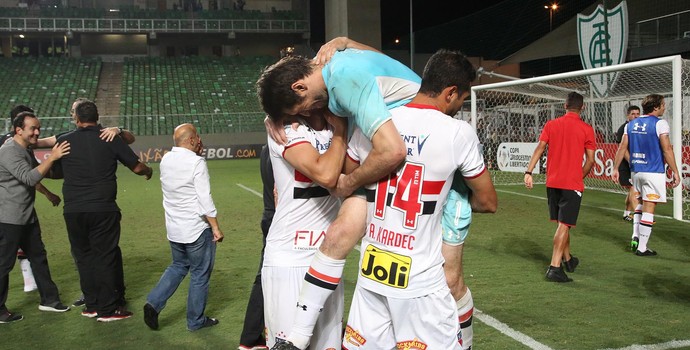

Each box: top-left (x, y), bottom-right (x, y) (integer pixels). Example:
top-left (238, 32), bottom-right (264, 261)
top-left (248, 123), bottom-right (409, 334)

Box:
top-left (120, 56), bottom-right (274, 135)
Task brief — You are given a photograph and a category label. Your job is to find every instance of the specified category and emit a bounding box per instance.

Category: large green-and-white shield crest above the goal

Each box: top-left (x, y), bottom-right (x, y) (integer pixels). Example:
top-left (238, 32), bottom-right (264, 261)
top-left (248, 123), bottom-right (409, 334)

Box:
top-left (577, 1), bottom-right (628, 97)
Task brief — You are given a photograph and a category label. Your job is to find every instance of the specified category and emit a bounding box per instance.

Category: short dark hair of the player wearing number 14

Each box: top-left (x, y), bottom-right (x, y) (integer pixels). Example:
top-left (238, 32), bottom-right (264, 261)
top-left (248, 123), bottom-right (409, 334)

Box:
top-left (419, 49), bottom-right (477, 97)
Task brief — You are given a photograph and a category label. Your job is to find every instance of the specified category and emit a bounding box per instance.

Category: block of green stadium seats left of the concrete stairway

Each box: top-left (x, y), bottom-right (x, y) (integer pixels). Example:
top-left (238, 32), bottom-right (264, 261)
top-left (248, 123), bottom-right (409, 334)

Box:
top-left (0, 57), bottom-right (101, 135)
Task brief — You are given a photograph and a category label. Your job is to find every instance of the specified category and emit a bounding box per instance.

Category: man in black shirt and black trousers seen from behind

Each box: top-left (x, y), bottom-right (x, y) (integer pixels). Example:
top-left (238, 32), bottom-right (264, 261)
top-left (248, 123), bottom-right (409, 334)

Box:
top-left (57, 101), bottom-right (152, 322)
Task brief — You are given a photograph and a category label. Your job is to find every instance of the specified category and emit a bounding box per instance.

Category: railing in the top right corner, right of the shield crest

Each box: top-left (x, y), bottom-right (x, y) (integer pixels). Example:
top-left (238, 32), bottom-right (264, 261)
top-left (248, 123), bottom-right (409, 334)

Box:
top-left (629, 10), bottom-right (690, 47)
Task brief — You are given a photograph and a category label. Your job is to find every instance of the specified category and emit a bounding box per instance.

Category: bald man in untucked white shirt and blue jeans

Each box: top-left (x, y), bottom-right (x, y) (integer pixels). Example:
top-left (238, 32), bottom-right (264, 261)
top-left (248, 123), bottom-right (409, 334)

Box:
top-left (144, 124), bottom-right (223, 331)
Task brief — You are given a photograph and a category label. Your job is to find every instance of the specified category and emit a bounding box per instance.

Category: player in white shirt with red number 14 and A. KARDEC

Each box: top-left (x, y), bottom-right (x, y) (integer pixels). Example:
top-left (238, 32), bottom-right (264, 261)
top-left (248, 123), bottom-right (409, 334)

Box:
top-left (343, 50), bottom-right (484, 349)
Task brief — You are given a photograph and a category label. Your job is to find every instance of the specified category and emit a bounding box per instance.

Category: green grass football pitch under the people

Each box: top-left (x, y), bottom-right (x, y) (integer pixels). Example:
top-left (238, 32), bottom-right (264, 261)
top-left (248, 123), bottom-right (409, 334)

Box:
top-left (0, 159), bottom-right (690, 350)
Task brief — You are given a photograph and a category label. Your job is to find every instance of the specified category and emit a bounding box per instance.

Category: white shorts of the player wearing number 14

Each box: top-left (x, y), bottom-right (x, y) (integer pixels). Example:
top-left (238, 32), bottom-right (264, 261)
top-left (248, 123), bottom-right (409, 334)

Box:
top-left (343, 287), bottom-right (462, 350)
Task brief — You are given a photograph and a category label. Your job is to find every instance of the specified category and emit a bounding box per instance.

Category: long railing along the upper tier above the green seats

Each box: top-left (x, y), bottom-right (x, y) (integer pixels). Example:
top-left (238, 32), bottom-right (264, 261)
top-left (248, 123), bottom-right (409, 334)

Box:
top-left (0, 17), bottom-right (309, 33)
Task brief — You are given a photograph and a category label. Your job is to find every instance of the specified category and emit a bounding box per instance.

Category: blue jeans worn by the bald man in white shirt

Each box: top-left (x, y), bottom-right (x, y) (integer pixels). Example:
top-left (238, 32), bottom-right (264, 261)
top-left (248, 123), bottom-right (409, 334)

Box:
top-left (146, 228), bottom-right (216, 331)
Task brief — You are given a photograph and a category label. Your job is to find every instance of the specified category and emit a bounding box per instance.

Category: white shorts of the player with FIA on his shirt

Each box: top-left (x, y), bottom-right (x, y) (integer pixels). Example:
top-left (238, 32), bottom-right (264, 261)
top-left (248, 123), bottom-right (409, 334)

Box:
top-left (261, 266), bottom-right (345, 350)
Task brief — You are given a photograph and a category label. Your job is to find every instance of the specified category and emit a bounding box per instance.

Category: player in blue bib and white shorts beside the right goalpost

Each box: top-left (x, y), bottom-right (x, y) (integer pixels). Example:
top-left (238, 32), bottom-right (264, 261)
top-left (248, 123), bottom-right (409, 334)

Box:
top-left (611, 94), bottom-right (680, 256)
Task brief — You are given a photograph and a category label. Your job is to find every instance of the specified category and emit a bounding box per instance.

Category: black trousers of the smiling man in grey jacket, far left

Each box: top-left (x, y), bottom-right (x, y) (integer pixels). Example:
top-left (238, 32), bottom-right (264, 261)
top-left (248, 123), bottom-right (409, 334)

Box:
top-left (0, 220), bottom-right (60, 312)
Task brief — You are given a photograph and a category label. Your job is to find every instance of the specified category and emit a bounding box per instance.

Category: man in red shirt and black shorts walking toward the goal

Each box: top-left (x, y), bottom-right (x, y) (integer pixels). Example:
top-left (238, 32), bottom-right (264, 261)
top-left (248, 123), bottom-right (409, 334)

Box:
top-left (525, 92), bottom-right (596, 282)
